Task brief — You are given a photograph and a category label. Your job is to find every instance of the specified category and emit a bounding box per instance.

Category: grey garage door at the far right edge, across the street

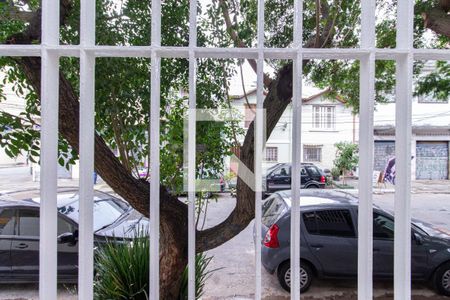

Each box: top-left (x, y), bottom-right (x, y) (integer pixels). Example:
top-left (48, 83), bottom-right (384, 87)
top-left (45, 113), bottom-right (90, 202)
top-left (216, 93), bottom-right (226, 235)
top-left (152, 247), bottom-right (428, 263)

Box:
top-left (416, 142), bottom-right (449, 180)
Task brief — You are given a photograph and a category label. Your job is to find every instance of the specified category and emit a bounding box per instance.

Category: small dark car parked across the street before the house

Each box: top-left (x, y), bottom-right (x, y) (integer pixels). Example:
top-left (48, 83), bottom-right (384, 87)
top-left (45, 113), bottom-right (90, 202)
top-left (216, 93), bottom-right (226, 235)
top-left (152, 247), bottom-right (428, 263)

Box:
top-left (265, 163), bottom-right (326, 193)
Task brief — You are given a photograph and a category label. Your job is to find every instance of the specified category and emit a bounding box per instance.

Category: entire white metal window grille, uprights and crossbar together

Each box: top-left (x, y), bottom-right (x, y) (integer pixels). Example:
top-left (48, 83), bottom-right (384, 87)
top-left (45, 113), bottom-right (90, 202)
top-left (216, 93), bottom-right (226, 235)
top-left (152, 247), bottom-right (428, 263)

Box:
top-left (0, 0), bottom-right (450, 300)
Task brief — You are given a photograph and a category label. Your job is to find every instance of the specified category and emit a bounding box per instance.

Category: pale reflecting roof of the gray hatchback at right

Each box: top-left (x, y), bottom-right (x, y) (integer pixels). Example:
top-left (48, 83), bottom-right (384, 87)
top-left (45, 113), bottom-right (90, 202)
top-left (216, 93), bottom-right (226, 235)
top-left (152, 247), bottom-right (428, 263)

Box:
top-left (276, 189), bottom-right (358, 208)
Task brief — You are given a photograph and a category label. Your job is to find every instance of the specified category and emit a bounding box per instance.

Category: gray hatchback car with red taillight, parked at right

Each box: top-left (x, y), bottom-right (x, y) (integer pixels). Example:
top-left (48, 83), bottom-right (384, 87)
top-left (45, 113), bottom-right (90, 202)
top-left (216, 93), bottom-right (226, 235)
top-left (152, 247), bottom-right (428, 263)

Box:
top-left (261, 190), bottom-right (450, 296)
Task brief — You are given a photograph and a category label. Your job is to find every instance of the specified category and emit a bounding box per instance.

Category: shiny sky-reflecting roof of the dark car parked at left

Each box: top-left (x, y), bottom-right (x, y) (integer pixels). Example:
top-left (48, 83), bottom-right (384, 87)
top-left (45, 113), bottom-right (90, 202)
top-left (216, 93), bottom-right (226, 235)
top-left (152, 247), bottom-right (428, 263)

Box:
top-left (0, 187), bottom-right (118, 208)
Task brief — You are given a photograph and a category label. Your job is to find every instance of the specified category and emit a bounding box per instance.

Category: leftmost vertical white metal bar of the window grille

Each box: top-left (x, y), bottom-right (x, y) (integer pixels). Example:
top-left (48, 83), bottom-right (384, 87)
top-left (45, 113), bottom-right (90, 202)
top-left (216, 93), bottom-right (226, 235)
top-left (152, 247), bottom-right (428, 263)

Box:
top-left (39, 0), bottom-right (59, 300)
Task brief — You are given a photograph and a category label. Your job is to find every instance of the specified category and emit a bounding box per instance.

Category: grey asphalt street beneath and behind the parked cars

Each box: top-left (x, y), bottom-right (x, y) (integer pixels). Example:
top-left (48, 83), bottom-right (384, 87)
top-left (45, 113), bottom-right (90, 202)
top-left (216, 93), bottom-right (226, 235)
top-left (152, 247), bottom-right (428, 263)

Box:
top-left (0, 167), bottom-right (450, 300)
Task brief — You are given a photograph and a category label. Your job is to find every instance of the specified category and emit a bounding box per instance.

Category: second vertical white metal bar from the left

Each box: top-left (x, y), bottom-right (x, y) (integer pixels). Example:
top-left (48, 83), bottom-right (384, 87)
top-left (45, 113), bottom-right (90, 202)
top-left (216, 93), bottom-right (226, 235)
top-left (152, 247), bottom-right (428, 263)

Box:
top-left (78, 0), bottom-right (95, 300)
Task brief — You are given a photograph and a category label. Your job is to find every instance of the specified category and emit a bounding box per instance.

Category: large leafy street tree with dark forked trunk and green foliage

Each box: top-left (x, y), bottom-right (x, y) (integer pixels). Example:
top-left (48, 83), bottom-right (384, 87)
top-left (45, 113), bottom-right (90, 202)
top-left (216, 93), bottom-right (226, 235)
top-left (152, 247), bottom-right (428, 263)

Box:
top-left (0, 0), bottom-right (450, 299)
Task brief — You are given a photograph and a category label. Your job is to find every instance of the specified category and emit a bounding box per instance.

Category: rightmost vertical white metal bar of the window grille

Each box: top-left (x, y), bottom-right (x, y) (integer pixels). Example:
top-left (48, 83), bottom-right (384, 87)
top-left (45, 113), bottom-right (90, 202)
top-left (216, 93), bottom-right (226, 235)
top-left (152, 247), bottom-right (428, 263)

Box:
top-left (394, 1), bottom-right (414, 300)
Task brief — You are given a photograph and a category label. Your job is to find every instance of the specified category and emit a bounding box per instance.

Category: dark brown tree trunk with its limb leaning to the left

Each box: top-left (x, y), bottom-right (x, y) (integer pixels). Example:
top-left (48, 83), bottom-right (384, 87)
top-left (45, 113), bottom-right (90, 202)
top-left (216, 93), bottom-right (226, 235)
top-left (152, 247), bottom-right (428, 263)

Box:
top-left (15, 57), bottom-right (188, 300)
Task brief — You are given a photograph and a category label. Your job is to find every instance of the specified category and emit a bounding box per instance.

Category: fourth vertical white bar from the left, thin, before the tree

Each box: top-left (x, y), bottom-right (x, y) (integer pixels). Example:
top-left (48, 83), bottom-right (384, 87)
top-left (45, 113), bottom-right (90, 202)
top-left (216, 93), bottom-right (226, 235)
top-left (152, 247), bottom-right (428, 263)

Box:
top-left (188, 0), bottom-right (197, 300)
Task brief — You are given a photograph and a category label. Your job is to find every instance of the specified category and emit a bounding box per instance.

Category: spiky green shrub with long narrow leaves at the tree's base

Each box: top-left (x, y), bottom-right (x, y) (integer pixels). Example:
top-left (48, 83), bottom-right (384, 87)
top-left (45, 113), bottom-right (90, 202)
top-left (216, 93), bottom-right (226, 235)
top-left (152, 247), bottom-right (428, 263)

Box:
top-left (94, 236), bottom-right (212, 300)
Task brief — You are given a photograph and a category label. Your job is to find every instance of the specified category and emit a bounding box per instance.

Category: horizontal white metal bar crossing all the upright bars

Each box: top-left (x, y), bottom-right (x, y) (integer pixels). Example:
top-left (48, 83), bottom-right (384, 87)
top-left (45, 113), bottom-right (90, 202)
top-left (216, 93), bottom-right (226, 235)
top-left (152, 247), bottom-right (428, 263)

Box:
top-left (0, 45), bottom-right (450, 60)
